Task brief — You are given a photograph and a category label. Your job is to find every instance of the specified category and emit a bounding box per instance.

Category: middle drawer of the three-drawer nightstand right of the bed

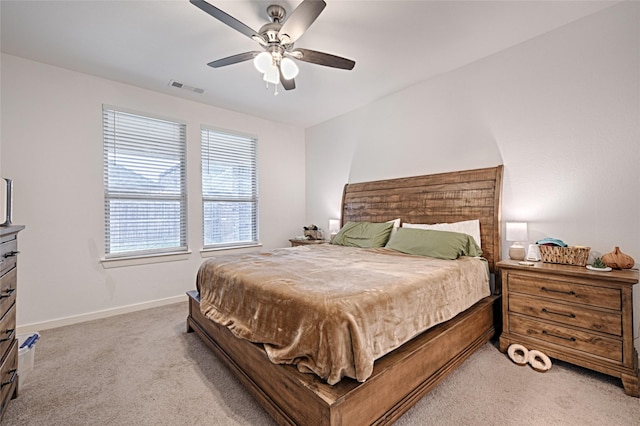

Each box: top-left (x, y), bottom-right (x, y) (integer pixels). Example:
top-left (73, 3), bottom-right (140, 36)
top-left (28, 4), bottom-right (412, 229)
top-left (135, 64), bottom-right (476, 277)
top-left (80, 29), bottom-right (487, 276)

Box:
top-left (509, 294), bottom-right (622, 336)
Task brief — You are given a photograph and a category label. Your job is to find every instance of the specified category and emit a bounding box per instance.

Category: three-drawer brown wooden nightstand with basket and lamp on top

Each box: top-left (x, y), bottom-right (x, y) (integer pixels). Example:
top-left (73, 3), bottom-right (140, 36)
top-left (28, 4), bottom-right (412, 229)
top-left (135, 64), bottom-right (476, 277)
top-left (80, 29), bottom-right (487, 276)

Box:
top-left (498, 260), bottom-right (639, 397)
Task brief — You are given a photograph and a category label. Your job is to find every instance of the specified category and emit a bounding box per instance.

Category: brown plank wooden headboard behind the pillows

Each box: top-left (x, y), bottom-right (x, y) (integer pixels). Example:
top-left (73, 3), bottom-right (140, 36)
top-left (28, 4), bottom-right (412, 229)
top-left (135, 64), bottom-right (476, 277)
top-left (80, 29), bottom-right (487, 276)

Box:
top-left (341, 165), bottom-right (503, 272)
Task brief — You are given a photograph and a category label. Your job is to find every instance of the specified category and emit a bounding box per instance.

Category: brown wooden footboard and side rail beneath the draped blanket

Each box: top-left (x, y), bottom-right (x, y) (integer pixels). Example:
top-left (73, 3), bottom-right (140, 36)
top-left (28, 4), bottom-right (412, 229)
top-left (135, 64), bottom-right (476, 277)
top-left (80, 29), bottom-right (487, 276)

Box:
top-left (187, 290), bottom-right (499, 426)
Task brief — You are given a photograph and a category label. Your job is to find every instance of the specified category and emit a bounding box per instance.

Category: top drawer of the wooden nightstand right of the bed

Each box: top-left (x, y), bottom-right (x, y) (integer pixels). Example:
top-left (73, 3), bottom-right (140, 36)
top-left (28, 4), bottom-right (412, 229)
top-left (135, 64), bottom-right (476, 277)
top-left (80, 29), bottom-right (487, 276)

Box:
top-left (508, 274), bottom-right (622, 311)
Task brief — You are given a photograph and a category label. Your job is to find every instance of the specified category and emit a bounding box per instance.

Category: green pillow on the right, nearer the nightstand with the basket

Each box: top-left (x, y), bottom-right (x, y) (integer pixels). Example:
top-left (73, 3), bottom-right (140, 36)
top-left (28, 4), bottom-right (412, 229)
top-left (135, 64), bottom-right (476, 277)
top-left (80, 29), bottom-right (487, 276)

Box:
top-left (386, 228), bottom-right (482, 260)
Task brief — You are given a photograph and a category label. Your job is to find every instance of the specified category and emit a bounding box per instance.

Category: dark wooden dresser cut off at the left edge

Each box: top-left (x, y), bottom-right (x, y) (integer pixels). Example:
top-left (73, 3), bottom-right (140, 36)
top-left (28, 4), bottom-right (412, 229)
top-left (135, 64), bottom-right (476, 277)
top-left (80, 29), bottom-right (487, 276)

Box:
top-left (0, 226), bottom-right (24, 420)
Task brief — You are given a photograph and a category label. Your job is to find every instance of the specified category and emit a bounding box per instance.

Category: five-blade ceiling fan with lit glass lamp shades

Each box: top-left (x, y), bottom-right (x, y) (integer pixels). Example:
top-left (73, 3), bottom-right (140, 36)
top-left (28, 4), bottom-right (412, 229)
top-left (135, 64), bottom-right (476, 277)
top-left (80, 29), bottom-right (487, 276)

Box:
top-left (189, 0), bottom-right (356, 94)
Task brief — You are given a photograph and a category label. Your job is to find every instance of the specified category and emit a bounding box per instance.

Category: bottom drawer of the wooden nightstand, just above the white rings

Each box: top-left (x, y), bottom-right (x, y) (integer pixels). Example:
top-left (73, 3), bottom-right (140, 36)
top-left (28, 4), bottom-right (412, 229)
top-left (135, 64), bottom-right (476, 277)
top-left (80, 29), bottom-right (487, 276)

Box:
top-left (509, 315), bottom-right (622, 362)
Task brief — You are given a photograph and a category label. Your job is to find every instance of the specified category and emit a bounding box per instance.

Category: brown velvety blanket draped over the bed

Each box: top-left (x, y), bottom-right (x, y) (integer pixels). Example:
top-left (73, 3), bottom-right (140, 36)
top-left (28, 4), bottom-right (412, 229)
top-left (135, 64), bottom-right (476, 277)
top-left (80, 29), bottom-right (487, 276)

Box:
top-left (197, 244), bottom-right (489, 384)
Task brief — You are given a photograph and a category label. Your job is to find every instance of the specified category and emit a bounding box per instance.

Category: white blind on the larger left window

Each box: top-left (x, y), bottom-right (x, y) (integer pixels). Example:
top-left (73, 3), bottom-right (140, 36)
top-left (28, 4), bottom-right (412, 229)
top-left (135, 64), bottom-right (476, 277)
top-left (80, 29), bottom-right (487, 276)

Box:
top-left (102, 106), bottom-right (187, 258)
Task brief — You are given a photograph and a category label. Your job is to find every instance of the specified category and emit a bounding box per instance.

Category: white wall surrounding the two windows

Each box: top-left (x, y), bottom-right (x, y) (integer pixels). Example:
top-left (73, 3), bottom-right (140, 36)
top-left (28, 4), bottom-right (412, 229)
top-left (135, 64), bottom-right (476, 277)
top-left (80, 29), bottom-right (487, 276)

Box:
top-left (1, 54), bottom-right (305, 327)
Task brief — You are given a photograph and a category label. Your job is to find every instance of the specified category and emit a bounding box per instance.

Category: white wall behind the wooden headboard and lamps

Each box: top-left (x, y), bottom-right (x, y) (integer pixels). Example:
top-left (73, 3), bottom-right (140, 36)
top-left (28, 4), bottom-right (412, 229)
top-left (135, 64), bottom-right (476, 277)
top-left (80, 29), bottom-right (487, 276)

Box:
top-left (306, 2), bottom-right (640, 346)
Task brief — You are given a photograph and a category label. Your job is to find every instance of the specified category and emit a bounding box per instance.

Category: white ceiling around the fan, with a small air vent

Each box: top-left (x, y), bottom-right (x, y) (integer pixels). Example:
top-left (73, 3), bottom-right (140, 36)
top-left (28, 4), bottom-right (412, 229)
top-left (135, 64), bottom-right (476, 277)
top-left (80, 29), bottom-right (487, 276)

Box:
top-left (0, 0), bottom-right (616, 127)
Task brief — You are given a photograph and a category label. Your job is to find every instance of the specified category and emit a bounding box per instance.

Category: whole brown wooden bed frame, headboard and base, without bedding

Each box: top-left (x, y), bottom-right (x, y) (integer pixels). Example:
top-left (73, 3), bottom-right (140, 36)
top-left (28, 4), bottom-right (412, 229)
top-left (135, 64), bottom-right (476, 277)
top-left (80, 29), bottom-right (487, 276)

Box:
top-left (187, 166), bottom-right (502, 425)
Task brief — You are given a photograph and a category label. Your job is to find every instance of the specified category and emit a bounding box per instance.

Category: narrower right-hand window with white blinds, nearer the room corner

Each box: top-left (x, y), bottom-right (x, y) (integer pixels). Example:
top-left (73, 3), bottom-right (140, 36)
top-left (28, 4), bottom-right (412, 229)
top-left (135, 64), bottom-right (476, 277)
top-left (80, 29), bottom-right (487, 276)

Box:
top-left (201, 128), bottom-right (258, 248)
